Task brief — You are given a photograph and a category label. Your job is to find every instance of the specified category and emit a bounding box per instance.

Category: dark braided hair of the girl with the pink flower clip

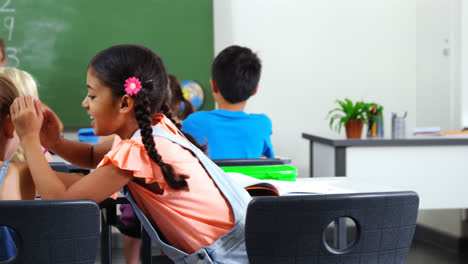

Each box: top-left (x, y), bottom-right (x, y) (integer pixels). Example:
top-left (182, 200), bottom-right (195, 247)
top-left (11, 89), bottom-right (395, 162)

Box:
top-left (88, 45), bottom-right (206, 190)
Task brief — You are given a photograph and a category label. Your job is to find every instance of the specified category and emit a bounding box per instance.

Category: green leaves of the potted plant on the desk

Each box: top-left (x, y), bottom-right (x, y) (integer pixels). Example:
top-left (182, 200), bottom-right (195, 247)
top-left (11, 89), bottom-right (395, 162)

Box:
top-left (328, 98), bottom-right (372, 133)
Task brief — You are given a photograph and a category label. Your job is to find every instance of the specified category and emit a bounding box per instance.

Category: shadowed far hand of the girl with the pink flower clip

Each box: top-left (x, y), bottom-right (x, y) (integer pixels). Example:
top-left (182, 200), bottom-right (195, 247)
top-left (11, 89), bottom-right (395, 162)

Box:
top-left (40, 106), bottom-right (63, 150)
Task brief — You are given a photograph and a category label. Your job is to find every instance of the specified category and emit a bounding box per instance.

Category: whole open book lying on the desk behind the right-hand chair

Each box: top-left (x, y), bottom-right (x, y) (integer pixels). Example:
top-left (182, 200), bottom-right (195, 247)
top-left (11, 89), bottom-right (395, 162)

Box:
top-left (227, 172), bottom-right (351, 196)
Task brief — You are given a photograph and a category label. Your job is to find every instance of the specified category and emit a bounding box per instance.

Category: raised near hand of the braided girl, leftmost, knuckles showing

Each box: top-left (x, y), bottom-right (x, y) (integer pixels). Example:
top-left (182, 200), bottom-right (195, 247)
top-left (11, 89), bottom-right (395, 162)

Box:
top-left (10, 96), bottom-right (43, 141)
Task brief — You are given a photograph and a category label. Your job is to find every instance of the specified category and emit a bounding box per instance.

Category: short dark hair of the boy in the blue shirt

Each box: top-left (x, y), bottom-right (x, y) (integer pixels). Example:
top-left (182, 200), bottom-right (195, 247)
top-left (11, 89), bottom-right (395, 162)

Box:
top-left (211, 45), bottom-right (262, 103)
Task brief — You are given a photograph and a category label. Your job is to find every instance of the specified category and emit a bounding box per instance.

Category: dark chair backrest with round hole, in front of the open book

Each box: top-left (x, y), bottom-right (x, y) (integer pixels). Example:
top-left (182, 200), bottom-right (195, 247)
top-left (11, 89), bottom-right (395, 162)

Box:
top-left (245, 192), bottom-right (419, 264)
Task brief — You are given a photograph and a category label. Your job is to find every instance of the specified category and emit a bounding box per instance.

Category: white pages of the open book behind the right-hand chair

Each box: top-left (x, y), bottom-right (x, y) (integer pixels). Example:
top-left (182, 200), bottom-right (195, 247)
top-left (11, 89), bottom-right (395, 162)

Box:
top-left (227, 172), bottom-right (350, 195)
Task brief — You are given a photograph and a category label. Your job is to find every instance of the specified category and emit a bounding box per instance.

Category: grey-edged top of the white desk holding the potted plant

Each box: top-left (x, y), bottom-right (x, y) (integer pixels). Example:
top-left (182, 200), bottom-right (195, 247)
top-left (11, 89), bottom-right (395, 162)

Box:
top-left (302, 133), bottom-right (468, 147)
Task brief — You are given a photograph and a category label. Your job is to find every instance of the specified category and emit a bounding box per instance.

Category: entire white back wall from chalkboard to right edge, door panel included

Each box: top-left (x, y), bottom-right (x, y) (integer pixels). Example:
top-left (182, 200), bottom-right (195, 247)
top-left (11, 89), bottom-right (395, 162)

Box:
top-left (213, 0), bottom-right (468, 239)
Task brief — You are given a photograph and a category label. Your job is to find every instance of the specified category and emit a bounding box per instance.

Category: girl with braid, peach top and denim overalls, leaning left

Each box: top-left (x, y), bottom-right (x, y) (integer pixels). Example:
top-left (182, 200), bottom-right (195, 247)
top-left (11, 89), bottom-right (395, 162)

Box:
top-left (10, 45), bottom-right (251, 263)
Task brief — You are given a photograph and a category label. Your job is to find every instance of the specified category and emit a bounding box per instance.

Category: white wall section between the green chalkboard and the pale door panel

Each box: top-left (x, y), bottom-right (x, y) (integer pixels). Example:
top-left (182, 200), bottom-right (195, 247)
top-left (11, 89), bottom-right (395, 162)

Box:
top-left (214, 0), bottom-right (416, 177)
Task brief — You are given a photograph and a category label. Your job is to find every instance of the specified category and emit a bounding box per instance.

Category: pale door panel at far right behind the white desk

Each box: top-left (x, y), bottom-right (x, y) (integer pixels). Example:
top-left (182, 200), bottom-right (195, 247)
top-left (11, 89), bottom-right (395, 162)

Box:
top-left (410, 0), bottom-right (460, 130)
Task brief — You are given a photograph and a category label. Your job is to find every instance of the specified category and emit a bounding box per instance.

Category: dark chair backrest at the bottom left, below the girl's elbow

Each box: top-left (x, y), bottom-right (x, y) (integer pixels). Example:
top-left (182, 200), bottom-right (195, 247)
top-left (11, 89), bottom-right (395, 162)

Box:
top-left (0, 200), bottom-right (100, 263)
